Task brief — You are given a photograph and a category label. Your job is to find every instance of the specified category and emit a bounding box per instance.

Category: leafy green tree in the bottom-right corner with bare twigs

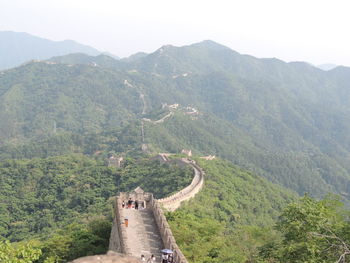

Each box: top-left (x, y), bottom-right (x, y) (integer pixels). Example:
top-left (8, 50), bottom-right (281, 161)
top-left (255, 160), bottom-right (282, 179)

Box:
top-left (260, 196), bottom-right (350, 263)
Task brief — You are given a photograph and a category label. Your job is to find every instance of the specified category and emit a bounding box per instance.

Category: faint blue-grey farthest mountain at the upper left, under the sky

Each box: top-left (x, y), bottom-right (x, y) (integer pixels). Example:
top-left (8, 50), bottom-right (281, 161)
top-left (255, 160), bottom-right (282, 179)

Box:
top-left (0, 31), bottom-right (101, 70)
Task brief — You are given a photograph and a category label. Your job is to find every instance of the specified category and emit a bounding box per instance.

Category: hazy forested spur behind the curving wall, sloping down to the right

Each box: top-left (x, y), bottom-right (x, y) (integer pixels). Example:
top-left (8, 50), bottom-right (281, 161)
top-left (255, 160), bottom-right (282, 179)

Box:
top-left (145, 112), bottom-right (350, 201)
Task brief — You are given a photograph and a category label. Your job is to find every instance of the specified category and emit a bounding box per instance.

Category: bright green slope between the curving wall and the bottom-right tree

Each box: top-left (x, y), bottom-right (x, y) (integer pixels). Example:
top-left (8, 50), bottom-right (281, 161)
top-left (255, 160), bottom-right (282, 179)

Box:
top-left (167, 160), bottom-right (295, 263)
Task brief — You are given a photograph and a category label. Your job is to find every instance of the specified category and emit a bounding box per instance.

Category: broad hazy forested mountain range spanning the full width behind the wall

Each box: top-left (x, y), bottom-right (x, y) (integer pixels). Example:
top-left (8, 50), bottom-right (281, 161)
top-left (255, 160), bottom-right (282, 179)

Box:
top-left (0, 40), bottom-right (350, 202)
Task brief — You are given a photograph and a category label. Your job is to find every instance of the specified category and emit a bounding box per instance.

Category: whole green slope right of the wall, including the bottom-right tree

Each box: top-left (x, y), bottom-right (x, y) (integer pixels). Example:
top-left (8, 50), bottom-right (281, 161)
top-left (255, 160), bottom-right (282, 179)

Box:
top-left (167, 160), bottom-right (350, 263)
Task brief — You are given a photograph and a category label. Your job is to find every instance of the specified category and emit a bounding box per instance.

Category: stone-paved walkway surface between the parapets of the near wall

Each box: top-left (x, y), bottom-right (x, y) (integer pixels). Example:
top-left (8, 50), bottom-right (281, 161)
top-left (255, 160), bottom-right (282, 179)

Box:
top-left (120, 208), bottom-right (164, 262)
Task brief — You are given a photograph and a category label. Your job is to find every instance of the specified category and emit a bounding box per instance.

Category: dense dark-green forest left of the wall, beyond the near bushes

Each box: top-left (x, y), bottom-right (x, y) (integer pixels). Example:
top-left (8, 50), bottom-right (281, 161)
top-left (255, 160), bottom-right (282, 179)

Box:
top-left (0, 155), bottom-right (193, 241)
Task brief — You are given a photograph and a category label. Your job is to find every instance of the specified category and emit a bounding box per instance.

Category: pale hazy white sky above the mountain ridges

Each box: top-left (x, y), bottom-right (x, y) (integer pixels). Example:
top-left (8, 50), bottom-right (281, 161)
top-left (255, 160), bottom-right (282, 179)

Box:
top-left (0, 0), bottom-right (350, 66)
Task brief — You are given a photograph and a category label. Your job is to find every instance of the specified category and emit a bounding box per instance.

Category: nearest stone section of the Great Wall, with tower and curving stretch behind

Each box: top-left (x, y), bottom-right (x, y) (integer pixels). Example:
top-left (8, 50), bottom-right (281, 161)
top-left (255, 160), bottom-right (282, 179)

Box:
top-left (109, 159), bottom-right (204, 263)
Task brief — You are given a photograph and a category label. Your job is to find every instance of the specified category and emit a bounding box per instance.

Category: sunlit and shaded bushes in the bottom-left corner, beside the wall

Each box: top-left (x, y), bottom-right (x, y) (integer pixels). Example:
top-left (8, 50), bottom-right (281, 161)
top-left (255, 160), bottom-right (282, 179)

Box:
top-left (0, 218), bottom-right (111, 263)
